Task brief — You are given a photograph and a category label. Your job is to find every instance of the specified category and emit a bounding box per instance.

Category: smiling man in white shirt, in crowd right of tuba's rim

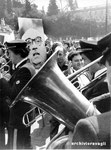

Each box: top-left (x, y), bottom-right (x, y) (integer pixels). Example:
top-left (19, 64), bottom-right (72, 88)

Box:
top-left (68, 50), bottom-right (90, 89)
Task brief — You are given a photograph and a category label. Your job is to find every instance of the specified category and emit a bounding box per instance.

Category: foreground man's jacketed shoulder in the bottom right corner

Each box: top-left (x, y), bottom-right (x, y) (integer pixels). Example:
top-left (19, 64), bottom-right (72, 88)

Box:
top-left (72, 111), bottom-right (111, 149)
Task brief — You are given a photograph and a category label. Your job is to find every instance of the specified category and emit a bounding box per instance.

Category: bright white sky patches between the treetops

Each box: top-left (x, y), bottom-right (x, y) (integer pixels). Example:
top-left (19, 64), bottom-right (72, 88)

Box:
top-left (33, 0), bottom-right (111, 11)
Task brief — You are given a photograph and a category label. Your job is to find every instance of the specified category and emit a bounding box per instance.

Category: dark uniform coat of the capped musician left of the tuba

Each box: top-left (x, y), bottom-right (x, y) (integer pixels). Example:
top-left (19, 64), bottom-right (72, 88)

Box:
top-left (0, 60), bottom-right (35, 128)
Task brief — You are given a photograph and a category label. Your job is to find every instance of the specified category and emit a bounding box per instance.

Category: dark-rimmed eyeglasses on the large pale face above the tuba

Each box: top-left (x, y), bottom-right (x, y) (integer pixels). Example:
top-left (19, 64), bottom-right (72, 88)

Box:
top-left (25, 36), bottom-right (42, 46)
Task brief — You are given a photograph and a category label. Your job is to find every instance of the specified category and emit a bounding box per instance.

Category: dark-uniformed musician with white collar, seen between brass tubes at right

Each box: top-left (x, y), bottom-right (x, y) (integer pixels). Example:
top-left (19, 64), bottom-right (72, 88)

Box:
top-left (82, 48), bottom-right (110, 113)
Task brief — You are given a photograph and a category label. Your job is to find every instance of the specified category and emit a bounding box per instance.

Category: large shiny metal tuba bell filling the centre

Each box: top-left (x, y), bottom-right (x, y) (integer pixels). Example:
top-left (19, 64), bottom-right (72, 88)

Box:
top-left (10, 52), bottom-right (100, 130)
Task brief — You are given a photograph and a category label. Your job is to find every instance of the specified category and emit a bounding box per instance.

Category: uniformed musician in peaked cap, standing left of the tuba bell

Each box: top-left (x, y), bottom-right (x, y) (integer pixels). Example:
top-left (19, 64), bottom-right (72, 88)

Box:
top-left (0, 39), bottom-right (35, 149)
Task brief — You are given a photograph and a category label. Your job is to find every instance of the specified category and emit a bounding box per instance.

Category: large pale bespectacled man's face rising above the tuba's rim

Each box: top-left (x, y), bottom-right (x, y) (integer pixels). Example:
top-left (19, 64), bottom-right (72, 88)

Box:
top-left (22, 28), bottom-right (47, 71)
